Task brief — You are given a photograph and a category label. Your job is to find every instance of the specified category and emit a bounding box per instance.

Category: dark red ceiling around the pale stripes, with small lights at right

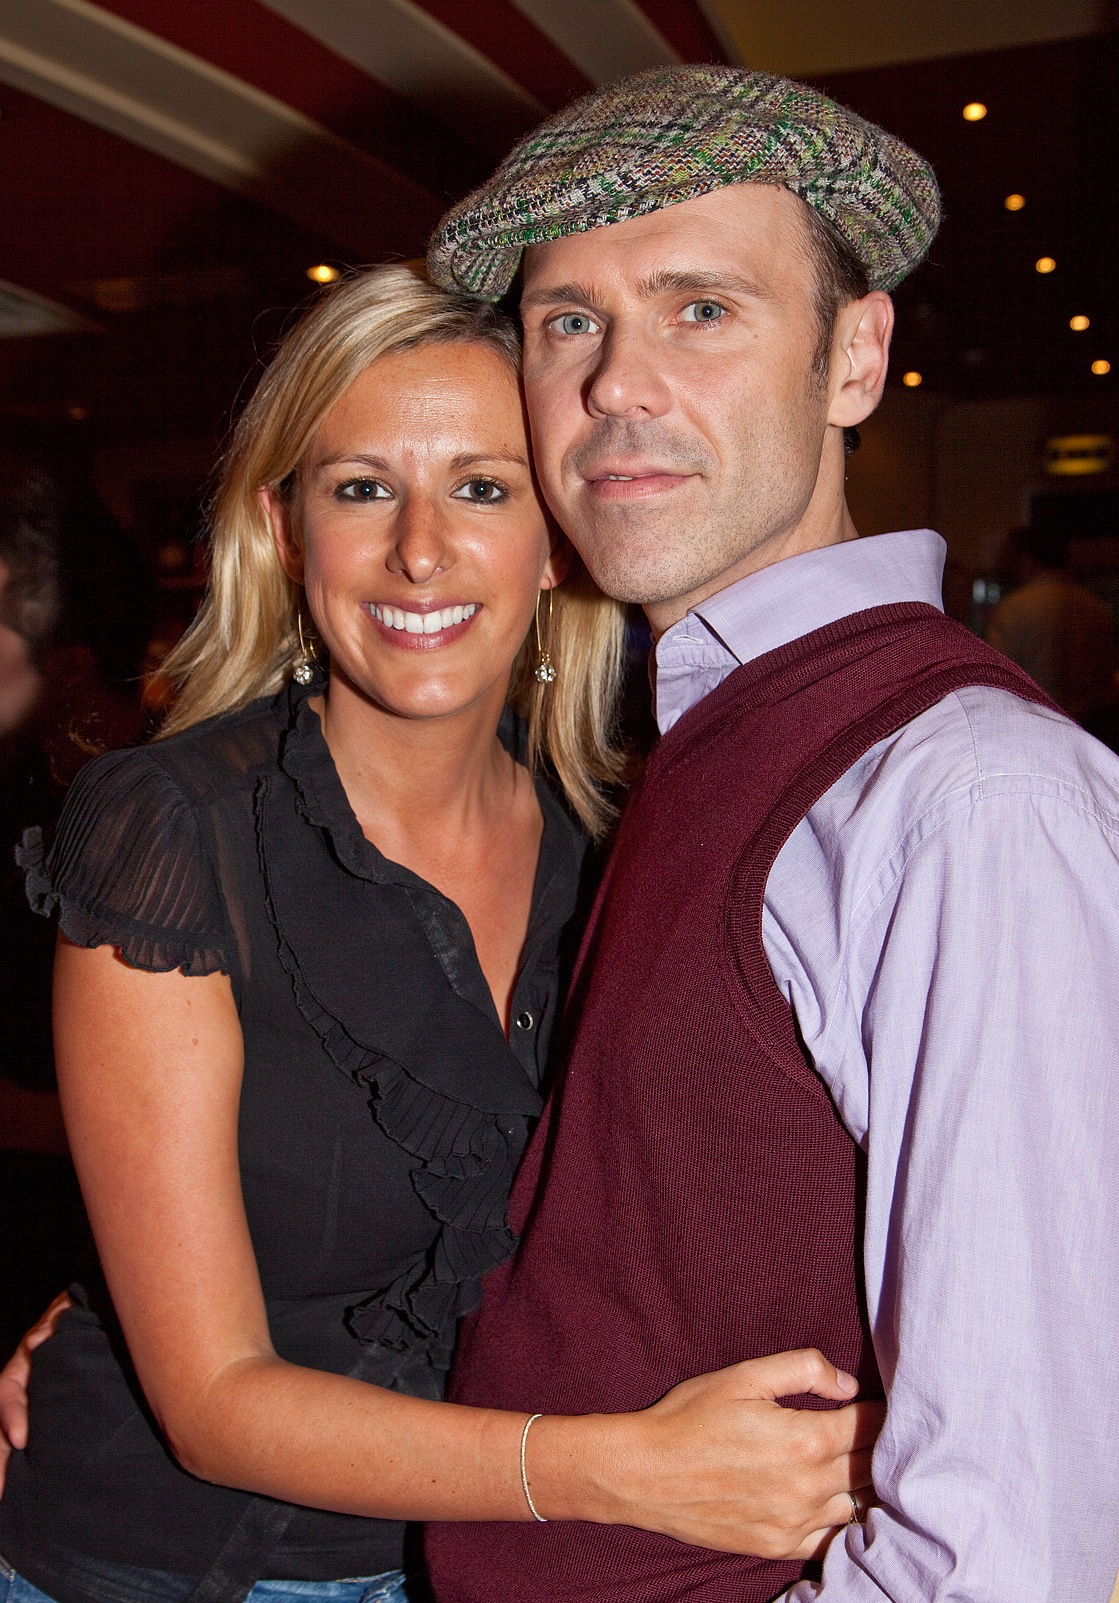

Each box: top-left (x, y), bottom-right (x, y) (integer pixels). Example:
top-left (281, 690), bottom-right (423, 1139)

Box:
top-left (0, 12), bottom-right (1119, 468)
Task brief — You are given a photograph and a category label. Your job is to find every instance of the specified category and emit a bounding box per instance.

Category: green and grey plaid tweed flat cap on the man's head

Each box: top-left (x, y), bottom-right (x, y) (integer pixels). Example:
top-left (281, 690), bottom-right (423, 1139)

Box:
top-left (428, 66), bottom-right (939, 300)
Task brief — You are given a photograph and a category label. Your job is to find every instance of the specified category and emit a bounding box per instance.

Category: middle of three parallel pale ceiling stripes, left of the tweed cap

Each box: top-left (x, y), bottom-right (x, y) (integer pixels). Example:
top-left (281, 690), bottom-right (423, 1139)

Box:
top-left (263, 0), bottom-right (547, 146)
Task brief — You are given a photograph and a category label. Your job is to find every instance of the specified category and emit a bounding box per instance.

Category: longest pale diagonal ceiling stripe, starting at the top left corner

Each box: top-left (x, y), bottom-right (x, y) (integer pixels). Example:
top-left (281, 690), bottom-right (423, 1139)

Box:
top-left (0, 0), bottom-right (433, 250)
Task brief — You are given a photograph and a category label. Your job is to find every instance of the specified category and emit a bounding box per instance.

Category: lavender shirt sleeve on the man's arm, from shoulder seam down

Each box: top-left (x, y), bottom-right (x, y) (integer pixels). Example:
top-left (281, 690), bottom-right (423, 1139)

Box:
top-left (789, 781), bottom-right (1119, 1603)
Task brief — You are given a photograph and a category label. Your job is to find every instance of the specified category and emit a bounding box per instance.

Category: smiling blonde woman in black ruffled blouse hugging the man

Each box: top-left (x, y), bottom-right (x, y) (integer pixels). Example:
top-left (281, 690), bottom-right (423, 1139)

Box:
top-left (0, 269), bottom-right (869, 1603)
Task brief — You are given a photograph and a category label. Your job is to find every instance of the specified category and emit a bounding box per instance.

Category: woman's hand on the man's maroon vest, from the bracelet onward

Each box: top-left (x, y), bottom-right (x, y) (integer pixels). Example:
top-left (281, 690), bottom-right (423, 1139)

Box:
top-left (526, 1348), bottom-right (885, 1558)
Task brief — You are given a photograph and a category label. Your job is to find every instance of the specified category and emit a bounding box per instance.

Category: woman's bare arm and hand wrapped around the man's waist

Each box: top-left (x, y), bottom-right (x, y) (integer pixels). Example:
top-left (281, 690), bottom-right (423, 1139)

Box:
top-left (55, 941), bottom-right (880, 1555)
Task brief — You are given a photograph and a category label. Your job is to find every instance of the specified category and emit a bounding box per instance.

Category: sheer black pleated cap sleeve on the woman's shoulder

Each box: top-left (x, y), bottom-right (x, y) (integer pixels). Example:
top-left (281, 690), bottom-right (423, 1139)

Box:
top-left (16, 750), bottom-right (231, 975)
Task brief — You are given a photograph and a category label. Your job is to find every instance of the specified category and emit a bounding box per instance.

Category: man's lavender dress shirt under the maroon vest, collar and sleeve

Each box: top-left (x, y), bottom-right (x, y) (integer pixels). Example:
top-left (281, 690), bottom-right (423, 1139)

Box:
top-left (656, 529), bottom-right (1119, 1603)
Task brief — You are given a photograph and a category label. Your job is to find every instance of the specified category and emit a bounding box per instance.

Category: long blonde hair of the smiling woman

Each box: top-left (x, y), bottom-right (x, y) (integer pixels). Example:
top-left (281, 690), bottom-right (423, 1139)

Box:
top-left (159, 268), bottom-right (625, 837)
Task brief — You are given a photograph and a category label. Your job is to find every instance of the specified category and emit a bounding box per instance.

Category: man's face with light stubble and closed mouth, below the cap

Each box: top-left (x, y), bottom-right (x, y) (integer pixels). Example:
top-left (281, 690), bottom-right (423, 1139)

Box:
top-left (521, 184), bottom-right (842, 627)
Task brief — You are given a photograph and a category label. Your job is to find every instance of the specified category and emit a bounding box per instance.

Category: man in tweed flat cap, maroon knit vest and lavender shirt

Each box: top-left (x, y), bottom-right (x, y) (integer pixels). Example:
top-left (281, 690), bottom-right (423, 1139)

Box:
top-left (428, 67), bottom-right (1119, 1603)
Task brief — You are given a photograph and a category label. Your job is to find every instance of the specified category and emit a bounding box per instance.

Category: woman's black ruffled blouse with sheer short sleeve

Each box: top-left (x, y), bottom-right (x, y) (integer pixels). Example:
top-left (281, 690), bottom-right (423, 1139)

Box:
top-left (0, 686), bottom-right (584, 1595)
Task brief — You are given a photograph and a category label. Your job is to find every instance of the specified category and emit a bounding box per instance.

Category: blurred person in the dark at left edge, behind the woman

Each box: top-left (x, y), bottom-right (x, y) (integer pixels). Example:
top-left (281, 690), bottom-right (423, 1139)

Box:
top-left (0, 474), bottom-right (152, 1342)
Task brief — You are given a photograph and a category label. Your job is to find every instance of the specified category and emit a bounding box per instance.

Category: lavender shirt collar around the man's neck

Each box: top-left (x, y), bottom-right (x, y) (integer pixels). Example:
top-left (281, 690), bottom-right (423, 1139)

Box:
top-left (654, 529), bottom-right (946, 734)
